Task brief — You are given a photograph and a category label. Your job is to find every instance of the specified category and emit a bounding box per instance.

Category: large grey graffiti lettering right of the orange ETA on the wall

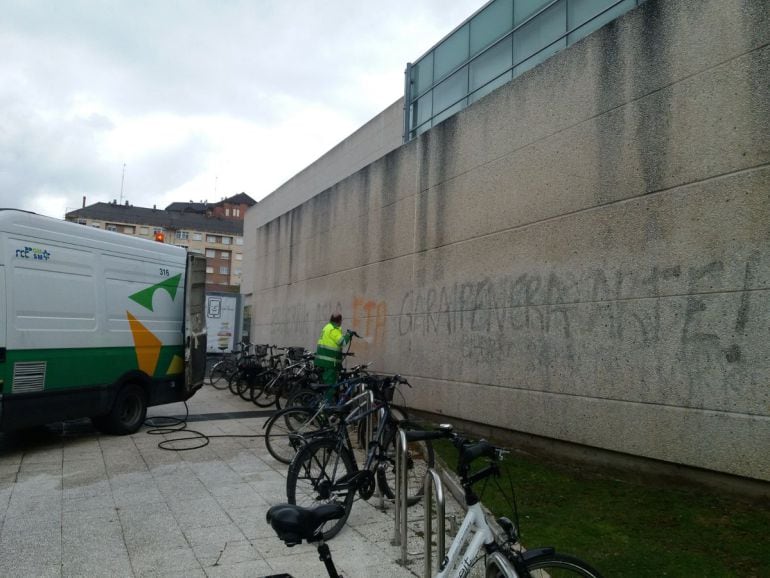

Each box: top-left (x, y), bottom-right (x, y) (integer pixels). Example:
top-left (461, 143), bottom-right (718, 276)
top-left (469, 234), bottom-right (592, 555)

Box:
top-left (392, 254), bottom-right (767, 404)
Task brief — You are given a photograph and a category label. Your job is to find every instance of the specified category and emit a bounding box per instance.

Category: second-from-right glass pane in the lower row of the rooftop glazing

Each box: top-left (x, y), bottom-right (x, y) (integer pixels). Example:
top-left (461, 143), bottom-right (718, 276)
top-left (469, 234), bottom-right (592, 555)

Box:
top-left (513, 0), bottom-right (567, 69)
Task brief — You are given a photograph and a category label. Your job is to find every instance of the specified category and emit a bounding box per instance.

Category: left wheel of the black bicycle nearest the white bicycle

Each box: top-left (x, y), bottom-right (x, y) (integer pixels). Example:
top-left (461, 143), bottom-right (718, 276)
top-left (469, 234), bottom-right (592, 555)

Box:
top-left (286, 438), bottom-right (357, 540)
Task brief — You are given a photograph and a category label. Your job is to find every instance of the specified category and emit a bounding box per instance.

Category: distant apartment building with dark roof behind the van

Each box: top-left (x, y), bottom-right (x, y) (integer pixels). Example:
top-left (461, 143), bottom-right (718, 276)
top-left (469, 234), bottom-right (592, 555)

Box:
top-left (65, 193), bottom-right (256, 291)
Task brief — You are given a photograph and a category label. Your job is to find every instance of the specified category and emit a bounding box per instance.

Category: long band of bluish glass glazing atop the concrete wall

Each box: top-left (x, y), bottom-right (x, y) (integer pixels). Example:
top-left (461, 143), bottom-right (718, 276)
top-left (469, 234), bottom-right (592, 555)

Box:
top-left (404, 0), bottom-right (644, 140)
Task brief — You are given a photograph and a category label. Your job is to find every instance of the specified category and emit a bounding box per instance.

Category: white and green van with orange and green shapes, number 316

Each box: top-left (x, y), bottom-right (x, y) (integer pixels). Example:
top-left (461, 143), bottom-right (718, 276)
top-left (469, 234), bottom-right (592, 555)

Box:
top-left (0, 209), bottom-right (206, 434)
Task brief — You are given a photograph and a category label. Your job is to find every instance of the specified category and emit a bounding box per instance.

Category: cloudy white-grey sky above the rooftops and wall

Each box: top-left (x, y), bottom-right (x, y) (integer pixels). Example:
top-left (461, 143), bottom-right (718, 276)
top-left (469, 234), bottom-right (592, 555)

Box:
top-left (0, 0), bottom-right (485, 218)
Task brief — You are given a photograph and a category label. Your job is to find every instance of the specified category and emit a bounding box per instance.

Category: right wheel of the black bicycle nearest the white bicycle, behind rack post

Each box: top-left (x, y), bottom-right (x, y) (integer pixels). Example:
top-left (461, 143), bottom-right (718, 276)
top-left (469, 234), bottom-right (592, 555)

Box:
top-left (377, 421), bottom-right (435, 506)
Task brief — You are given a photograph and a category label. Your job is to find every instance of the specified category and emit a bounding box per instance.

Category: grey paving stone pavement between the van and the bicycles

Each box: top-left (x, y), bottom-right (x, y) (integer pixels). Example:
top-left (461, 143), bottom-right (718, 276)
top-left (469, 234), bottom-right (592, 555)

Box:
top-left (0, 386), bottom-right (461, 578)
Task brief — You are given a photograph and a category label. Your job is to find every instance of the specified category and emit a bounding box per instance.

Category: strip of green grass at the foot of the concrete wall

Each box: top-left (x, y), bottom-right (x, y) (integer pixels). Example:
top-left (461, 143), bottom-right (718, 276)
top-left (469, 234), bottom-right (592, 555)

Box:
top-left (434, 441), bottom-right (770, 578)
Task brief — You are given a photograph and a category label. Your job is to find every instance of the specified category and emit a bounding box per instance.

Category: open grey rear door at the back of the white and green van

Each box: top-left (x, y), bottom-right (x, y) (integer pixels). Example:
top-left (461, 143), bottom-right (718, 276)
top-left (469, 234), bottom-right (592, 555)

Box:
top-left (184, 253), bottom-right (206, 396)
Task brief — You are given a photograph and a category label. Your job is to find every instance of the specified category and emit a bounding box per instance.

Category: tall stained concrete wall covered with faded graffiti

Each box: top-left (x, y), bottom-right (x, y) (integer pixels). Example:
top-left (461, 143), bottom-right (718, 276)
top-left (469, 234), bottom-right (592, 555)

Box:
top-left (245, 0), bottom-right (770, 481)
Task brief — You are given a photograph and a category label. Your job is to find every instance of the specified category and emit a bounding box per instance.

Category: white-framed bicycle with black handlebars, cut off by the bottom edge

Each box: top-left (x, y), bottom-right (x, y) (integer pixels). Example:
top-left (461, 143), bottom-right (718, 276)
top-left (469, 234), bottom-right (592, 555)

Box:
top-left (406, 424), bottom-right (601, 578)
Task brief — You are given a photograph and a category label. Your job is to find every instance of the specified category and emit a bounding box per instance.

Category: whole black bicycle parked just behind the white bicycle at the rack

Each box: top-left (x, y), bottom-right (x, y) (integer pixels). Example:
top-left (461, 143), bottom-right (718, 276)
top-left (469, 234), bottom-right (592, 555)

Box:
top-left (286, 375), bottom-right (434, 540)
